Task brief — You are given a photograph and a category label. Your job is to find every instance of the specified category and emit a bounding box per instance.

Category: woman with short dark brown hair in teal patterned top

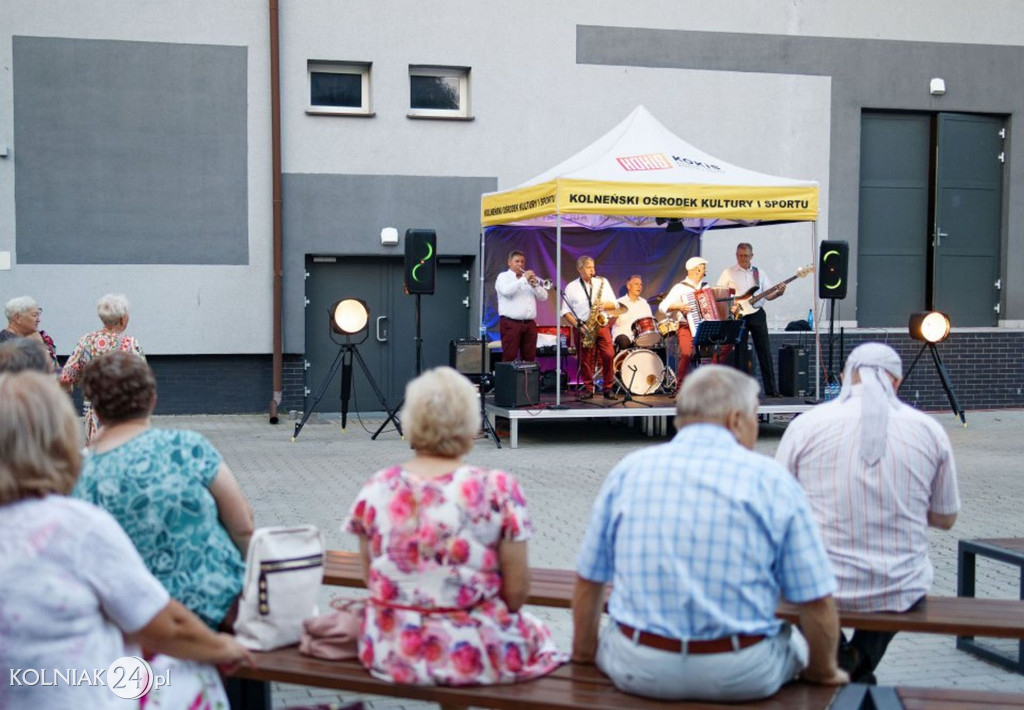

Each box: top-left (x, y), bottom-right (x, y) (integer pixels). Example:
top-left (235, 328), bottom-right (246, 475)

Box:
top-left (74, 352), bottom-right (253, 628)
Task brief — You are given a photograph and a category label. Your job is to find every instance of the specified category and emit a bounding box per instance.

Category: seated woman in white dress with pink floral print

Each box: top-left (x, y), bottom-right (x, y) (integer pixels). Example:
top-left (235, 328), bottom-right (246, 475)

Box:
top-left (343, 368), bottom-right (567, 685)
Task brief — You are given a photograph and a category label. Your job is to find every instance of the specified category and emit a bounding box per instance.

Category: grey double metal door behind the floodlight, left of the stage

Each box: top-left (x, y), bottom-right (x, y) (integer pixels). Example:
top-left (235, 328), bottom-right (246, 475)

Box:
top-left (305, 256), bottom-right (471, 413)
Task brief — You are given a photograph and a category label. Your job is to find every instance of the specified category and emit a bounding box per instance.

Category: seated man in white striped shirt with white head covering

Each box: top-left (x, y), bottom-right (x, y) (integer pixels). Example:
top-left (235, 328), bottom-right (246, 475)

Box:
top-left (775, 343), bottom-right (959, 682)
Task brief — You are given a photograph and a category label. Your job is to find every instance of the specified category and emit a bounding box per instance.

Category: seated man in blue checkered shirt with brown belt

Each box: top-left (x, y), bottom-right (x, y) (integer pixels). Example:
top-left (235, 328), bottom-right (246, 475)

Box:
top-left (572, 365), bottom-right (849, 702)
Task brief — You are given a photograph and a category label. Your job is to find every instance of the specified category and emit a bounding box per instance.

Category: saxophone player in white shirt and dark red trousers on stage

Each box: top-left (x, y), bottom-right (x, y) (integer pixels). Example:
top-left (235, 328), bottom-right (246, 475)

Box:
top-left (561, 256), bottom-right (618, 400)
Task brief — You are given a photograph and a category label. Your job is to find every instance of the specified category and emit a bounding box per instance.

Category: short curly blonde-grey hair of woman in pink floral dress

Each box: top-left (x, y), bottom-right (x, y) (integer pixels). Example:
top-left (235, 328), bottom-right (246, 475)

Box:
top-left (400, 367), bottom-right (480, 457)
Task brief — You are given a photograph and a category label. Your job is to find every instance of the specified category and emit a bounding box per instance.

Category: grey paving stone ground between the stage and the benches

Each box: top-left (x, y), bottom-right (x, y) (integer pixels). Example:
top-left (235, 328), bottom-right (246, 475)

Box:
top-left (149, 411), bottom-right (1024, 710)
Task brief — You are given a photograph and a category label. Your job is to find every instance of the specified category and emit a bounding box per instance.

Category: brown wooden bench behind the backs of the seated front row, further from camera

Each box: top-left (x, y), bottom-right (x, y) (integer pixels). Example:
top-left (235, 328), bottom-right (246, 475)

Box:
top-left (324, 550), bottom-right (1024, 638)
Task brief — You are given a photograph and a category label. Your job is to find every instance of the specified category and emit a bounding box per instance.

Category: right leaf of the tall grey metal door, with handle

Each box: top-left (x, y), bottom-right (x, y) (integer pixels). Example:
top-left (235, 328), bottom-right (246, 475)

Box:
top-left (932, 114), bottom-right (1005, 326)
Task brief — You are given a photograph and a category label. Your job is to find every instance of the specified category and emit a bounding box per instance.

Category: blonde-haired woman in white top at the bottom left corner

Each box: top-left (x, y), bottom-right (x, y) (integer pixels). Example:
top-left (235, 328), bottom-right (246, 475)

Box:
top-left (0, 372), bottom-right (252, 710)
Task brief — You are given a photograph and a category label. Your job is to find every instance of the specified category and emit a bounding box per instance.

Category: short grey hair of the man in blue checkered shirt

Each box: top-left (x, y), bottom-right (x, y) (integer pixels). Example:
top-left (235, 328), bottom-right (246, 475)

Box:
top-left (676, 365), bottom-right (761, 428)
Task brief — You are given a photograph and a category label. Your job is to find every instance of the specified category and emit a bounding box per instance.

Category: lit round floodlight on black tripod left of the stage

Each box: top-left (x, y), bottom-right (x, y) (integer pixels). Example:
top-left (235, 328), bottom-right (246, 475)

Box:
top-left (292, 298), bottom-right (401, 442)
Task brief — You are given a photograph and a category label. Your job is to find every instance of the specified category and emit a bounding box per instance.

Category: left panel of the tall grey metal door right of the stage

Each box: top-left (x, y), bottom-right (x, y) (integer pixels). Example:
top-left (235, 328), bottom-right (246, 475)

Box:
top-left (857, 113), bottom-right (932, 327)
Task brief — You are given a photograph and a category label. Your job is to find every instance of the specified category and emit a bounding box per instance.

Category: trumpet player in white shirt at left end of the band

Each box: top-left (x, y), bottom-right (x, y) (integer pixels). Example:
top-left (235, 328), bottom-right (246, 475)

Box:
top-left (495, 250), bottom-right (548, 363)
